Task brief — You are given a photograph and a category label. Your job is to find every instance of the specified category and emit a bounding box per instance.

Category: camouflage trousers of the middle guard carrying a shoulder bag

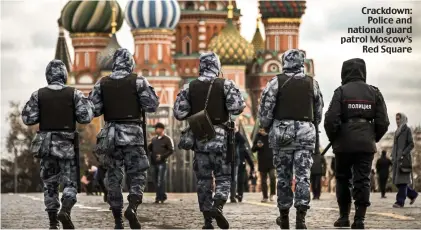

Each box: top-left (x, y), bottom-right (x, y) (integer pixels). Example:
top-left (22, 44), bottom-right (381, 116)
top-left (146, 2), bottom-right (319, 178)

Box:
top-left (193, 152), bottom-right (231, 212)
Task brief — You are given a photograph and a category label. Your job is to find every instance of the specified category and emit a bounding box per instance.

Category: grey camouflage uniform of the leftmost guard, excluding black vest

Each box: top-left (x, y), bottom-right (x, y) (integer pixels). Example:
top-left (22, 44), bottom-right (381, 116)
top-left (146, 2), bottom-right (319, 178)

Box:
top-left (22, 60), bottom-right (93, 228)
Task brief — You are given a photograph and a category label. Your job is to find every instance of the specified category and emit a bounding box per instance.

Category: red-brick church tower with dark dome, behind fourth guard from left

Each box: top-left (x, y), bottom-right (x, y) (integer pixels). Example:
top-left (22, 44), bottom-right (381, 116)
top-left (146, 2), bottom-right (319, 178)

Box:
top-left (246, 1), bottom-right (314, 117)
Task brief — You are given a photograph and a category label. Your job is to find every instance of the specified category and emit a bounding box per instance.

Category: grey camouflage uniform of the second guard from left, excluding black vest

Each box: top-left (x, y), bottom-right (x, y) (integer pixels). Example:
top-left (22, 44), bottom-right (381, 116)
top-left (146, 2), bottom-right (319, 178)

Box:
top-left (89, 48), bottom-right (159, 227)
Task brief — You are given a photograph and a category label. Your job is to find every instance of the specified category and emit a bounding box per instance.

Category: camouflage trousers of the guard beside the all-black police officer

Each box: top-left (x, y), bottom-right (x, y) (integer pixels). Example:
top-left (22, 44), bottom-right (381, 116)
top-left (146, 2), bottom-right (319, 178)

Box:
top-left (273, 150), bottom-right (313, 209)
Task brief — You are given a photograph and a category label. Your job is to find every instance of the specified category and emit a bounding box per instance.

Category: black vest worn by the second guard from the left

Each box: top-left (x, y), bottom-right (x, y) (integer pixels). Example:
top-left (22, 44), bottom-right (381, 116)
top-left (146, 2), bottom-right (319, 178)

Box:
top-left (100, 73), bottom-right (141, 121)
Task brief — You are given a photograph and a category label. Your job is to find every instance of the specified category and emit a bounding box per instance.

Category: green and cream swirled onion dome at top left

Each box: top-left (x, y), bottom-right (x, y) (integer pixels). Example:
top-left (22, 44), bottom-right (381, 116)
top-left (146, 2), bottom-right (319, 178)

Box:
top-left (61, 0), bottom-right (124, 33)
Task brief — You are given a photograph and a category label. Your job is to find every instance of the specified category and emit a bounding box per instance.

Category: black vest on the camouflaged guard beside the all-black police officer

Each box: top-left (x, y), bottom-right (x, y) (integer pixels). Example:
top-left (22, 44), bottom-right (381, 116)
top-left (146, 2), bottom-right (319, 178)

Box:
top-left (274, 74), bottom-right (314, 121)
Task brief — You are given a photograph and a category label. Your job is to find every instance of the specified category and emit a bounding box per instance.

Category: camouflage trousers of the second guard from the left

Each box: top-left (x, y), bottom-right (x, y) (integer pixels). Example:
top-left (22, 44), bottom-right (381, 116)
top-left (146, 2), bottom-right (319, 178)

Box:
top-left (106, 146), bottom-right (149, 208)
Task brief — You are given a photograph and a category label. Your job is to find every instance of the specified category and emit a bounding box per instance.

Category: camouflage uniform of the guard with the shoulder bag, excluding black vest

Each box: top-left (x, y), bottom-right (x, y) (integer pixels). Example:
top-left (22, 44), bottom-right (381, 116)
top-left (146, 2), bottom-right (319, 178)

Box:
top-left (174, 53), bottom-right (245, 228)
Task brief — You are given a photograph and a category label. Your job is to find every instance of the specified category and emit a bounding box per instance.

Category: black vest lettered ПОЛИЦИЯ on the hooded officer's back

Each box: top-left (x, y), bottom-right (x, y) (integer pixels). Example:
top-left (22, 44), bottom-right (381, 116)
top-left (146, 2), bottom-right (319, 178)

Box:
top-left (341, 81), bottom-right (376, 122)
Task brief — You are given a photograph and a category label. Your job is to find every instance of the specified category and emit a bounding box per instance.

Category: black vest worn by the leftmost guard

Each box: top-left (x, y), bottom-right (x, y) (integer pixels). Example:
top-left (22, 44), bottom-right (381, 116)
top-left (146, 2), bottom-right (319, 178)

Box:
top-left (38, 87), bottom-right (76, 132)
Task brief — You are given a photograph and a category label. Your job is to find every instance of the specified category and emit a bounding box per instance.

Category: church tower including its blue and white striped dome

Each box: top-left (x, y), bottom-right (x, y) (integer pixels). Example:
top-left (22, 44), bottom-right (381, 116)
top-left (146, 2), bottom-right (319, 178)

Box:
top-left (125, 0), bottom-right (181, 125)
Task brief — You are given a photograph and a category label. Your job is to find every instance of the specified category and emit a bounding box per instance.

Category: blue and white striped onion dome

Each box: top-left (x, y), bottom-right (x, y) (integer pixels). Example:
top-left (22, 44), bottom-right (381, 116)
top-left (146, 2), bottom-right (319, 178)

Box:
top-left (125, 0), bottom-right (180, 30)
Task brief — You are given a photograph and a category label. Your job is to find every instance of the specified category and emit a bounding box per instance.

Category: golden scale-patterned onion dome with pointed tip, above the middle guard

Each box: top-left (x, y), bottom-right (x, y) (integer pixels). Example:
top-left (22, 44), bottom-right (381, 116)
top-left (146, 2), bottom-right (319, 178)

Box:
top-left (208, 19), bottom-right (254, 65)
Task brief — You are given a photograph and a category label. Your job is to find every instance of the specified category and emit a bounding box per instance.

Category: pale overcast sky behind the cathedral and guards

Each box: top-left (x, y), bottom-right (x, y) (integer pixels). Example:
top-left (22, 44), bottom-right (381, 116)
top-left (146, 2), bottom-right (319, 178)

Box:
top-left (0, 0), bottom-right (421, 153)
